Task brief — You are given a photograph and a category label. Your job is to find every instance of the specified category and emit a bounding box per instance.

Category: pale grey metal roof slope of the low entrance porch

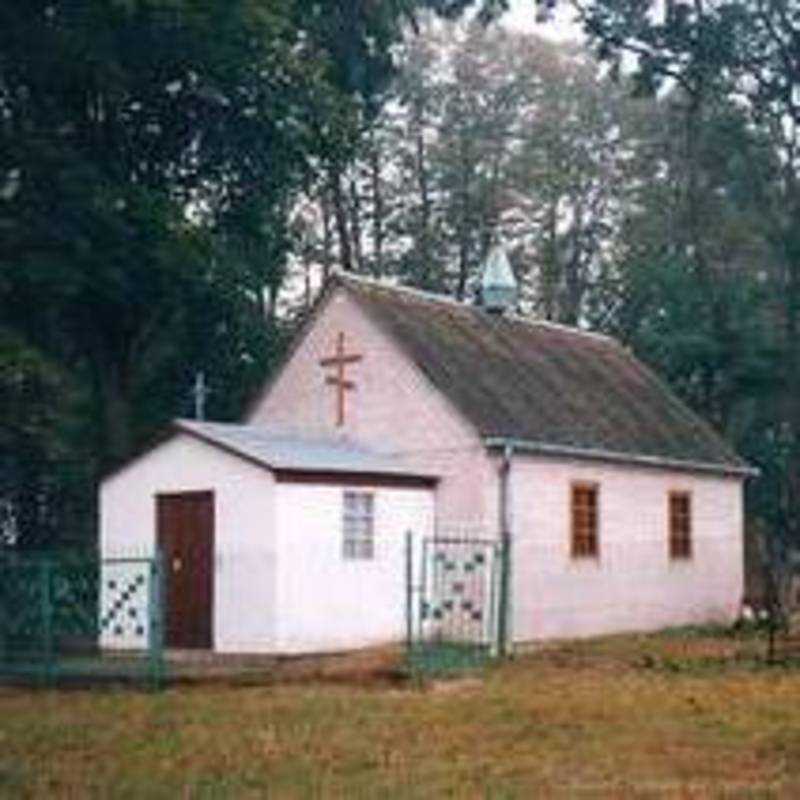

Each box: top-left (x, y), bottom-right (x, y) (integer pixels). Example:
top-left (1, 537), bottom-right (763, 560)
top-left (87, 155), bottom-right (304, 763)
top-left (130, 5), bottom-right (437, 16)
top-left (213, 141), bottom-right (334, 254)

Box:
top-left (174, 420), bottom-right (436, 481)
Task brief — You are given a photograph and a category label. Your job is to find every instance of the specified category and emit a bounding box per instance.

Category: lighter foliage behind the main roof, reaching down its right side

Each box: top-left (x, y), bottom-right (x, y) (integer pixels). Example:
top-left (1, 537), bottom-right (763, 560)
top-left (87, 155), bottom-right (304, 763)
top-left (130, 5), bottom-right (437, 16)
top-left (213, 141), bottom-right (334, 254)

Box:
top-left (296, 15), bottom-right (800, 572)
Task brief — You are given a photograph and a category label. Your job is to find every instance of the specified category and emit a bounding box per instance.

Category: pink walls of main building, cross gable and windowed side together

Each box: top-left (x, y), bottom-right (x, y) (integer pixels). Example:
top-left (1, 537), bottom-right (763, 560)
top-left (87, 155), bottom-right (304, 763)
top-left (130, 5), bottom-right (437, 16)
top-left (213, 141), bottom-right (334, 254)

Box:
top-left (248, 289), bottom-right (743, 642)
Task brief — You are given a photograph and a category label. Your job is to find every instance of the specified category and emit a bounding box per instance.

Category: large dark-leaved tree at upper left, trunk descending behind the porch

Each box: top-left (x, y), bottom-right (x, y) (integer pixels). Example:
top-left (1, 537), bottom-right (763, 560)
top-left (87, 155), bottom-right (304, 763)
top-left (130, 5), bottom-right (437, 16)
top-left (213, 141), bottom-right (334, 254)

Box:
top-left (0, 0), bottom-right (324, 464)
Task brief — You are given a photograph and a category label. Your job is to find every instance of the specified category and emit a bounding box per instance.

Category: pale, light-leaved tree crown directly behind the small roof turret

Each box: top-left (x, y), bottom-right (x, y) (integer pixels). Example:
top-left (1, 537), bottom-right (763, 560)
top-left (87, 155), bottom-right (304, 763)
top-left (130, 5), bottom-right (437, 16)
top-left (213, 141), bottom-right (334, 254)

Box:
top-left (305, 21), bottom-right (627, 322)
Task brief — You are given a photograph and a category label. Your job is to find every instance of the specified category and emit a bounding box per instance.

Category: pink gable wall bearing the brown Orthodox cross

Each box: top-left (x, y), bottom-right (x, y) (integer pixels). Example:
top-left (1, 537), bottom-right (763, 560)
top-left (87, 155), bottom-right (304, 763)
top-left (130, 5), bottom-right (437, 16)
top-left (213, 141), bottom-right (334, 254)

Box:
top-left (253, 289), bottom-right (496, 534)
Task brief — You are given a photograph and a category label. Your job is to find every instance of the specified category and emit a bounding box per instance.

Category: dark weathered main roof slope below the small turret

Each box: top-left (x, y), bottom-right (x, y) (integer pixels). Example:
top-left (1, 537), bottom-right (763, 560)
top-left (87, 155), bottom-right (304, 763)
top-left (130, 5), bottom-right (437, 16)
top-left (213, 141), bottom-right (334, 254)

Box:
top-left (334, 275), bottom-right (749, 472)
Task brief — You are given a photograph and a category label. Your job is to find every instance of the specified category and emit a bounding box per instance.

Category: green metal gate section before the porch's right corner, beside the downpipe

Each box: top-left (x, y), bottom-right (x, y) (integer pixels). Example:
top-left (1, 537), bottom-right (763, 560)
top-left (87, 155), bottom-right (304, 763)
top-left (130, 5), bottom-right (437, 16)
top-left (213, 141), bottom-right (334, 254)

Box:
top-left (406, 534), bottom-right (507, 673)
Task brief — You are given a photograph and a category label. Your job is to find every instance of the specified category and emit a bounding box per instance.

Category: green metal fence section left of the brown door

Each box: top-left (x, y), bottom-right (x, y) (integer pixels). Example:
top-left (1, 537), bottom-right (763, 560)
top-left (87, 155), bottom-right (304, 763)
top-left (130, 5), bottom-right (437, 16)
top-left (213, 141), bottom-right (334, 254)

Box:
top-left (0, 553), bottom-right (164, 688)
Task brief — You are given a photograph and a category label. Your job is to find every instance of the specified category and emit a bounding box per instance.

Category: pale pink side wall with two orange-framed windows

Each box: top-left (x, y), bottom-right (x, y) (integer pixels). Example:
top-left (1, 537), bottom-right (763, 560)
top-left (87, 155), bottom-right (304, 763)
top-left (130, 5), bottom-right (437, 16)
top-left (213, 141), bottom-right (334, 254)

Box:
top-left (511, 455), bottom-right (743, 642)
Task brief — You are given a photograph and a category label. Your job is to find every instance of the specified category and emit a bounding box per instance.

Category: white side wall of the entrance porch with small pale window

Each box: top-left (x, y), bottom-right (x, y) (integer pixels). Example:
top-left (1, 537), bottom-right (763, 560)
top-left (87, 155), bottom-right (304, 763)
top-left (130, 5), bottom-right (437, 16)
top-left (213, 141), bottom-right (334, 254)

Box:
top-left (276, 483), bottom-right (434, 653)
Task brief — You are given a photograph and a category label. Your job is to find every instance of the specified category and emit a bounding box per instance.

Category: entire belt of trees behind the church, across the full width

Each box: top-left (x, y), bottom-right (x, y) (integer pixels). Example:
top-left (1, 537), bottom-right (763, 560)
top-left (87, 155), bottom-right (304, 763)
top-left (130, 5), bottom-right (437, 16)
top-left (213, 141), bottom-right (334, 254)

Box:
top-left (0, 0), bottom-right (800, 564)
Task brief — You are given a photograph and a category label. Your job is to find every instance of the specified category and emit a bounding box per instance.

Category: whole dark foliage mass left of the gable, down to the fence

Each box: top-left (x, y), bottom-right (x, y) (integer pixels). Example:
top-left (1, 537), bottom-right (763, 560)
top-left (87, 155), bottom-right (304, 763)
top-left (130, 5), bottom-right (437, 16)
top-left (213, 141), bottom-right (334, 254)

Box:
top-left (0, 0), bottom-right (460, 543)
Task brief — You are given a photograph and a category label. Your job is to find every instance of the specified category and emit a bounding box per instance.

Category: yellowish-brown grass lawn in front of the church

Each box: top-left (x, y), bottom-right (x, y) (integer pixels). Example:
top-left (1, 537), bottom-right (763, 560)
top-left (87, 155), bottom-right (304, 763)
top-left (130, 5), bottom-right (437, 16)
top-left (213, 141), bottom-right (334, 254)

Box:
top-left (0, 632), bottom-right (800, 798)
